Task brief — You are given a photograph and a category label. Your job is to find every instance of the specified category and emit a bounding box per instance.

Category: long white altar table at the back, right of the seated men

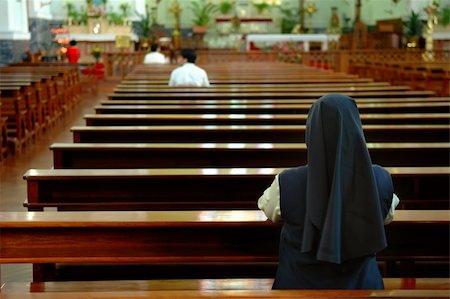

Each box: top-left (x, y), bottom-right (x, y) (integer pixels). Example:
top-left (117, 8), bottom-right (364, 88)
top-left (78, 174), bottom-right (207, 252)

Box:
top-left (245, 34), bottom-right (340, 52)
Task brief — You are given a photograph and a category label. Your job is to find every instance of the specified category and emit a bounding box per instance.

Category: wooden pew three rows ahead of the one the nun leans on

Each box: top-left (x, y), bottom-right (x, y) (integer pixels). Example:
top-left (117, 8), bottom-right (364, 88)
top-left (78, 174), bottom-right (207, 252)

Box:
top-left (71, 124), bottom-right (450, 143)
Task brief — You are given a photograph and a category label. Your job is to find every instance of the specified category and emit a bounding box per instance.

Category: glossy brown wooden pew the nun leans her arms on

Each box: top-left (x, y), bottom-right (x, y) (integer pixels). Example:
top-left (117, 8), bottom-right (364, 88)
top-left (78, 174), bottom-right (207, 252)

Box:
top-left (0, 211), bottom-right (450, 281)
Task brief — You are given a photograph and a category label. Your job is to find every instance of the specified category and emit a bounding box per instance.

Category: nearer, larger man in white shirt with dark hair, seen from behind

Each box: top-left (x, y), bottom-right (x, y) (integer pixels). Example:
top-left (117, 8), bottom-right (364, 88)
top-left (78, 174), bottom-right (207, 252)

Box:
top-left (169, 49), bottom-right (210, 87)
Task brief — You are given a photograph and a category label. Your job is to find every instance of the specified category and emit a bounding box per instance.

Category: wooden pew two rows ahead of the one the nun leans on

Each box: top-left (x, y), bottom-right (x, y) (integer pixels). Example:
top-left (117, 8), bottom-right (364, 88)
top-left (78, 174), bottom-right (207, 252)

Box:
top-left (50, 142), bottom-right (450, 169)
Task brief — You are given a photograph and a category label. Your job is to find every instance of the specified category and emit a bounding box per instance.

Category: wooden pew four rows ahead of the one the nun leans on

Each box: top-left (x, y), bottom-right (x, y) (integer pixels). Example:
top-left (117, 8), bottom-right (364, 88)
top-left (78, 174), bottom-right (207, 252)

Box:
top-left (84, 113), bottom-right (450, 126)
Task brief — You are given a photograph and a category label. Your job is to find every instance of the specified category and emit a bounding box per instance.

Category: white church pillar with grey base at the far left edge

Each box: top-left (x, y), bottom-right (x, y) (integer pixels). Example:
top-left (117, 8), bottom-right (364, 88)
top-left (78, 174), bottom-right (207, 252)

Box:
top-left (0, 0), bottom-right (30, 64)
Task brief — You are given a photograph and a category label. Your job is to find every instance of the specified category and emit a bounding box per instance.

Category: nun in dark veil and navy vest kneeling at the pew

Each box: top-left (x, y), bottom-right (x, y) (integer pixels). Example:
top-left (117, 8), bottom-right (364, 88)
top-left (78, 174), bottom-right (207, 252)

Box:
top-left (258, 94), bottom-right (399, 290)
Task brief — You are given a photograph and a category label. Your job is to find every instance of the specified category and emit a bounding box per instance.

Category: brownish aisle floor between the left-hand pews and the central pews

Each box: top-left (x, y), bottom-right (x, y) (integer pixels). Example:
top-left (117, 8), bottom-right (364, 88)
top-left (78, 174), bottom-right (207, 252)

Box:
top-left (0, 81), bottom-right (118, 282)
